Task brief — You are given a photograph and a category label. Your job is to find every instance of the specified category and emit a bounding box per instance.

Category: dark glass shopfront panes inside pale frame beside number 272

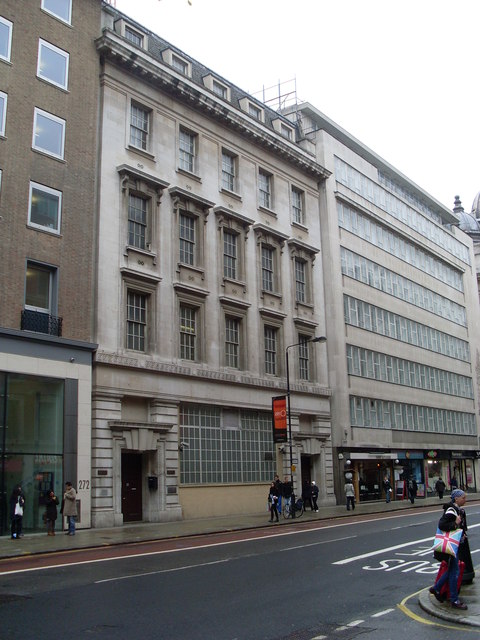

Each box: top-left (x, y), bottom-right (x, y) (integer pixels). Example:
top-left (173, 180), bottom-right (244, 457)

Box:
top-left (0, 372), bottom-right (65, 534)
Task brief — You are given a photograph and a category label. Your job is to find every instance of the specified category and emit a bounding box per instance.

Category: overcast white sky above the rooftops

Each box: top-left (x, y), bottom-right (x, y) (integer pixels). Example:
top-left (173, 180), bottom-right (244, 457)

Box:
top-left (113, 0), bottom-right (480, 212)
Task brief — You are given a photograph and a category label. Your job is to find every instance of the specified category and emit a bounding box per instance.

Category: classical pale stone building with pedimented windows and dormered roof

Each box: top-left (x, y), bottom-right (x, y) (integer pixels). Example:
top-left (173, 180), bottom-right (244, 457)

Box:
top-left (92, 6), bottom-right (335, 526)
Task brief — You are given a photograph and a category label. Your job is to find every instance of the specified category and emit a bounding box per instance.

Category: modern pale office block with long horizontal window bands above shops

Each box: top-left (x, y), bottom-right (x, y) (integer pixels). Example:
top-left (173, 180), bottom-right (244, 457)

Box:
top-left (288, 104), bottom-right (480, 500)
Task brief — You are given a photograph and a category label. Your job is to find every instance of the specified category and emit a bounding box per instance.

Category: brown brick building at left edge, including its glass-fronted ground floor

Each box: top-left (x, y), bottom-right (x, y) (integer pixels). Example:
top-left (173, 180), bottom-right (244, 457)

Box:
top-left (0, 0), bottom-right (101, 533)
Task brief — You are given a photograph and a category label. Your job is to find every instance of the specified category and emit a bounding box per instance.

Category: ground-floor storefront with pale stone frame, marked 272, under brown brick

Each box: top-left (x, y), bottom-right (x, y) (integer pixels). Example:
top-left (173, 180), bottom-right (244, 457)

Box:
top-left (0, 329), bottom-right (94, 535)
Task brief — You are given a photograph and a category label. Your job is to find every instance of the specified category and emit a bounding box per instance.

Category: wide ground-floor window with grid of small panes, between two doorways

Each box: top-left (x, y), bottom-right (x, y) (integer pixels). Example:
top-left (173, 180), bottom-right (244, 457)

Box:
top-left (180, 405), bottom-right (274, 484)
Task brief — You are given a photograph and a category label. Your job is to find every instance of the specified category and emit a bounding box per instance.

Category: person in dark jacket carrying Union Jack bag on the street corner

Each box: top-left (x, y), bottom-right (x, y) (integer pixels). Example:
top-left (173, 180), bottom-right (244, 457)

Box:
top-left (429, 489), bottom-right (468, 610)
